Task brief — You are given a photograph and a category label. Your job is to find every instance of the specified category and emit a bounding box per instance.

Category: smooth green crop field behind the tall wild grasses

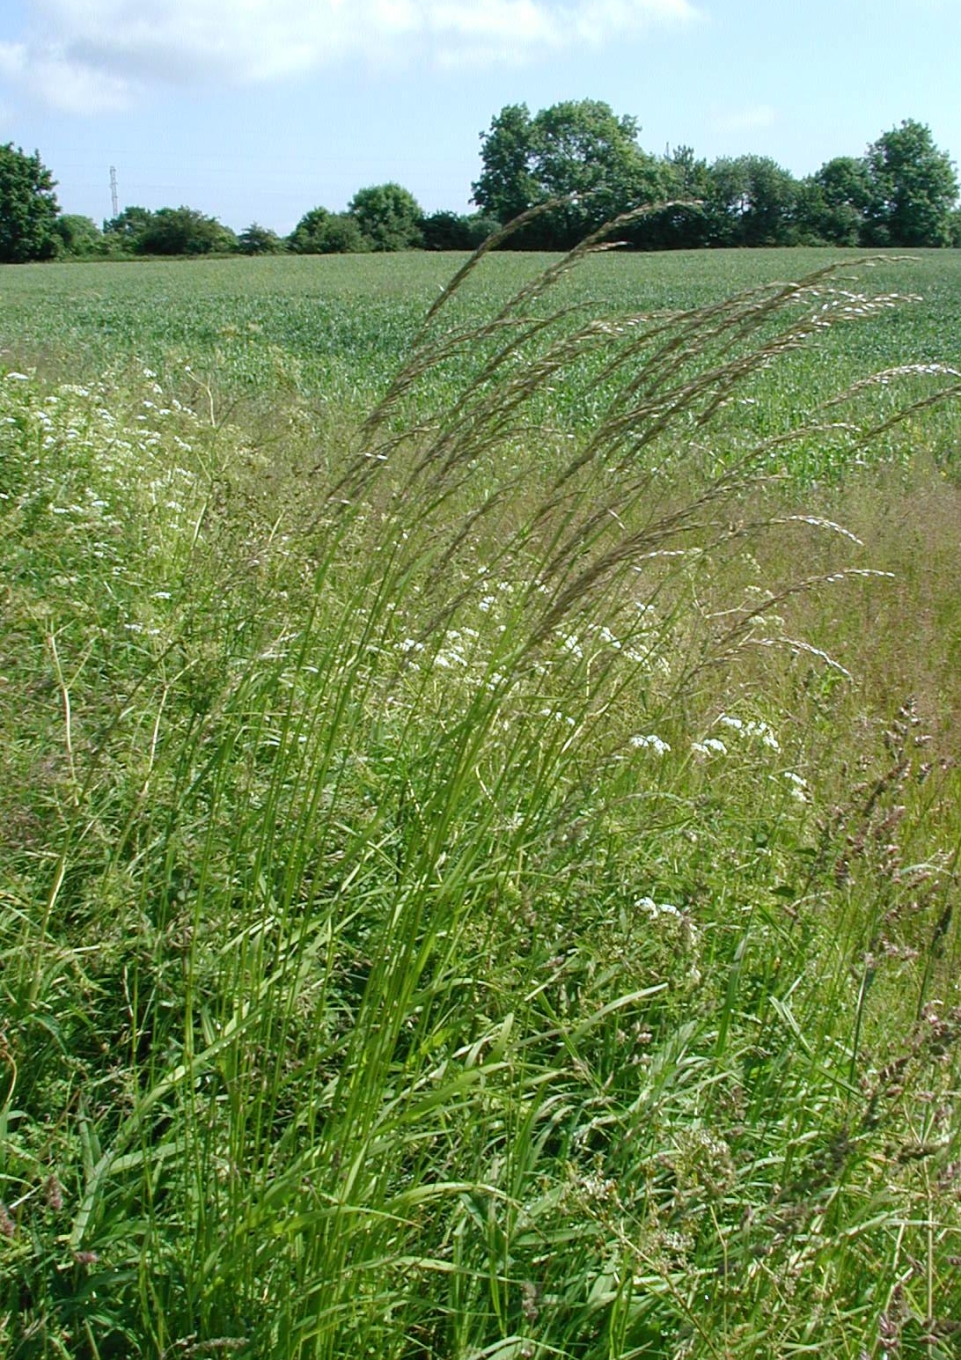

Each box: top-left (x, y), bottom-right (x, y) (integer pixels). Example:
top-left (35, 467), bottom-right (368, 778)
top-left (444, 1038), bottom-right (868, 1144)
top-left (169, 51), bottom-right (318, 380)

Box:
top-left (0, 250), bottom-right (961, 470)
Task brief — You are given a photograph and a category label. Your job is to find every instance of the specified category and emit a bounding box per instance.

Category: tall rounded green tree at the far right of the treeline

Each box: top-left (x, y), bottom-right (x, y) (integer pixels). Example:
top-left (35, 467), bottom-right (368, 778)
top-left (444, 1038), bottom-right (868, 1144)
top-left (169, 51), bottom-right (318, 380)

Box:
top-left (864, 118), bottom-right (958, 246)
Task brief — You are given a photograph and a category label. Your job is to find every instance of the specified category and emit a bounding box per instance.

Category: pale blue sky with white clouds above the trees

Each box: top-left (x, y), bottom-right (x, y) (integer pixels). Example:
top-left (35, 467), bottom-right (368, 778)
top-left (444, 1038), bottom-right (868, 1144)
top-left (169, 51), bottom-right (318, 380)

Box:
top-left (0, 0), bottom-right (961, 234)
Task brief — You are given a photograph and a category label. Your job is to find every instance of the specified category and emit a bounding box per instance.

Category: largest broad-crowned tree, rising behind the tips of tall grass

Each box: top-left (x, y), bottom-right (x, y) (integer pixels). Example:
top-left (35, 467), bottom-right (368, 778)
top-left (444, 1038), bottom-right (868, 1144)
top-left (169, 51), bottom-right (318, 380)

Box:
top-left (473, 99), bottom-right (665, 249)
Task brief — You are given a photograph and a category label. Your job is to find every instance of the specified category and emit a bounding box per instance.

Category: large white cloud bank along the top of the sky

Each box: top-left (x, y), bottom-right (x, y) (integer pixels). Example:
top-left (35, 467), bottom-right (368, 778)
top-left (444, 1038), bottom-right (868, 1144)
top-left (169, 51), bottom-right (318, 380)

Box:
top-left (0, 0), bottom-right (699, 113)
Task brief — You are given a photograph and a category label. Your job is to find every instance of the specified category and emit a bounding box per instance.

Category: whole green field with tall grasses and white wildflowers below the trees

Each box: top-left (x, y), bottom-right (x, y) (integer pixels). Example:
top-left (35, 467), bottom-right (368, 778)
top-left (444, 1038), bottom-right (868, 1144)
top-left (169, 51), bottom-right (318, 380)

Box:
top-left (0, 250), bottom-right (961, 1360)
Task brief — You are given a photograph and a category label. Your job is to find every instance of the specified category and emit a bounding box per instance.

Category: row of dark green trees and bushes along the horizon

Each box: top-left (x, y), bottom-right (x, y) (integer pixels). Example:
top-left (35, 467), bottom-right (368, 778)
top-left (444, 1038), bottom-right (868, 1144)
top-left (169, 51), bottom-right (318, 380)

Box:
top-left (0, 99), bottom-right (961, 262)
